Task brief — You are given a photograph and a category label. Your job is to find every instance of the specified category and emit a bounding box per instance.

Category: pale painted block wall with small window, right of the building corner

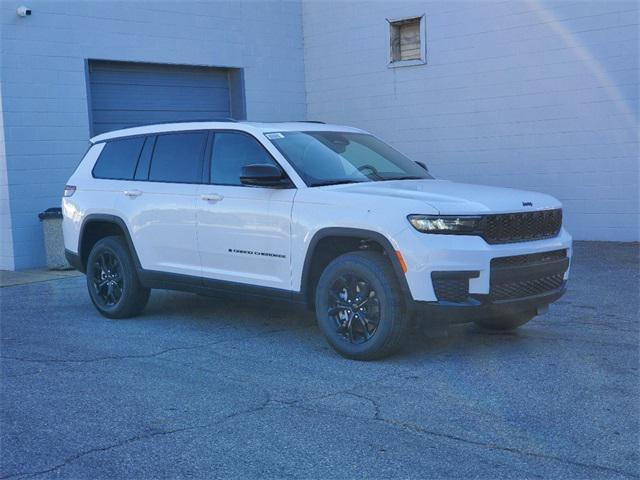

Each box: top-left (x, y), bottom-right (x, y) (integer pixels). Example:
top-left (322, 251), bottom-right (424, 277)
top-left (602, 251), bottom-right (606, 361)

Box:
top-left (303, 0), bottom-right (640, 241)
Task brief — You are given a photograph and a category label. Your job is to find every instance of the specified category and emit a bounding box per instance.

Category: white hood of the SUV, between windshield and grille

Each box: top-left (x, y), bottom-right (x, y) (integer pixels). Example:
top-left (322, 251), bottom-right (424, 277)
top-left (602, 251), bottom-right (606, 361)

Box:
top-left (330, 180), bottom-right (561, 215)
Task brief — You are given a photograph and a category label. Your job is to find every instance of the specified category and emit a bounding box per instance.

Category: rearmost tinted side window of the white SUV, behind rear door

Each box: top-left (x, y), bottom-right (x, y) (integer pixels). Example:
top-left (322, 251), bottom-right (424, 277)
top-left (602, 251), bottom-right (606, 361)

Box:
top-left (93, 137), bottom-right (144, 180)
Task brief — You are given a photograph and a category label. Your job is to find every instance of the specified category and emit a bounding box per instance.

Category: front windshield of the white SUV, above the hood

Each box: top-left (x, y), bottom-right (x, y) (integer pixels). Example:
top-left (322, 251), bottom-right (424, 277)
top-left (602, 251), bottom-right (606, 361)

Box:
top-left (265, 132), bottom-right (433, 187)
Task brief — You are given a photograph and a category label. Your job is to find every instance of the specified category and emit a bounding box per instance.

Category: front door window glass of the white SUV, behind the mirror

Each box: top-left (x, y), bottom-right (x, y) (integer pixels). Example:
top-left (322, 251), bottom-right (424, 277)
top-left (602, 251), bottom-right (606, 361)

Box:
top-left (210, 133), bottom-right (277, 185)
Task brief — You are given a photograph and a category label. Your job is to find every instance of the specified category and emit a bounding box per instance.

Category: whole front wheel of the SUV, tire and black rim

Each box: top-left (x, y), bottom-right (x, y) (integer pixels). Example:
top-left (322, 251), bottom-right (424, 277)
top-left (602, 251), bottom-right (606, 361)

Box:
top-left (315, 251), bottom-right (410, 360)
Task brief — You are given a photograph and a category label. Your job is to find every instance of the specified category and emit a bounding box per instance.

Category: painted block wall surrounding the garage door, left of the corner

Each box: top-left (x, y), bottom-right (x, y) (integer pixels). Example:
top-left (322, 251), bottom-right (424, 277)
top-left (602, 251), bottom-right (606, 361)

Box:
top-left (0, 0), bottom-right (306, 269)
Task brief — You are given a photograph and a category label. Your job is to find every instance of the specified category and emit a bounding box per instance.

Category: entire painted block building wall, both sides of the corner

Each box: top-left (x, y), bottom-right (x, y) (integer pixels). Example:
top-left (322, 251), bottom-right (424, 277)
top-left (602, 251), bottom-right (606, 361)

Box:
top-left (0, 0), bottom-right (640, 268)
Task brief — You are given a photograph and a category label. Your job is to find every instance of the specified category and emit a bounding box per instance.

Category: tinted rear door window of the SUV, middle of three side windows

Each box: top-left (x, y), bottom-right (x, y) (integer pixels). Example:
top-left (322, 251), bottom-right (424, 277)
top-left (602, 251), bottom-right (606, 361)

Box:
top-left (149, 132), bottom-right (207, 183)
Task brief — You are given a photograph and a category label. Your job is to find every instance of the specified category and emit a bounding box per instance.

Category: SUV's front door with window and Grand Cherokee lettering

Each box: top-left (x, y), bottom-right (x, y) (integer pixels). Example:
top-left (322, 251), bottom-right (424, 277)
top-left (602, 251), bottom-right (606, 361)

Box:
top-left (197, 131), bottom-right (296, 290)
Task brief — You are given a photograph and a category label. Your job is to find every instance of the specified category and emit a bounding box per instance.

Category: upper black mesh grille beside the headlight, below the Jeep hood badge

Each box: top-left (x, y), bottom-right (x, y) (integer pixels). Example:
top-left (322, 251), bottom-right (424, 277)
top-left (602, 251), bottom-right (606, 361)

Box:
top-left (482, 209), bottom-right (562, 244)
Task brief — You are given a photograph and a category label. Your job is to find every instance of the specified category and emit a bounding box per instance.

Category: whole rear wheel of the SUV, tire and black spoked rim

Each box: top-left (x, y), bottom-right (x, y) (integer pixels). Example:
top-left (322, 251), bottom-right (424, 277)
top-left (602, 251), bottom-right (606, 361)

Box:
top-left (87, 236), bottom-right (150, 318)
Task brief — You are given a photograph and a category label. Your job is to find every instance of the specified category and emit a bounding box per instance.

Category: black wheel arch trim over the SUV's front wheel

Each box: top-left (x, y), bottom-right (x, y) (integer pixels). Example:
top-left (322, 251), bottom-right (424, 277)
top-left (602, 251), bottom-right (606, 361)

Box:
top-left (300, 227), bottom-right (413, 306)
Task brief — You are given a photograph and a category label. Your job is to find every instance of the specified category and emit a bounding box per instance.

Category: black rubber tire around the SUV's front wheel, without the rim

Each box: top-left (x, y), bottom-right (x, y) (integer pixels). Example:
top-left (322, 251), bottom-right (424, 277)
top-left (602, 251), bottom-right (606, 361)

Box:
top-left (315, 256), bottom-right (399, 359)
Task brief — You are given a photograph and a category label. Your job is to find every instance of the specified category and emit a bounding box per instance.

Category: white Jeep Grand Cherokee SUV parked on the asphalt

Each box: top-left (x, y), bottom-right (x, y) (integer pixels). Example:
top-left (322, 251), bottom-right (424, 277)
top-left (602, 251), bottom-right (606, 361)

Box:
top-left (62, 121), bottom-right (571, 359)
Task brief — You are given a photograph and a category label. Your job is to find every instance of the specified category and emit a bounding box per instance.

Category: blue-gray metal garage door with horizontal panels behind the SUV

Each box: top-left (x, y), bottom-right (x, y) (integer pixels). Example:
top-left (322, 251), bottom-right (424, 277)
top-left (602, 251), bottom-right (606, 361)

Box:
top-left (89, 60), bottom-right (231, 135)
